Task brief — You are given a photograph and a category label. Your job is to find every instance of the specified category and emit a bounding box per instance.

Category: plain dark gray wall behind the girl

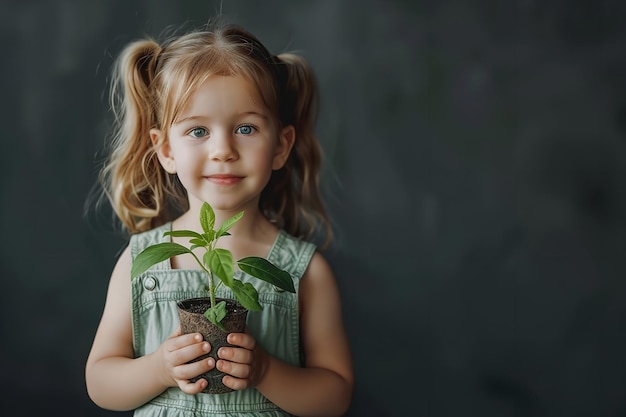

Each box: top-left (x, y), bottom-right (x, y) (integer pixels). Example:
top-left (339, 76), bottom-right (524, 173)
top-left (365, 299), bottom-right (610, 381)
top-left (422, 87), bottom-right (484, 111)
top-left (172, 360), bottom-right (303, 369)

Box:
top-left (0, 0), bottom-right (626, 417)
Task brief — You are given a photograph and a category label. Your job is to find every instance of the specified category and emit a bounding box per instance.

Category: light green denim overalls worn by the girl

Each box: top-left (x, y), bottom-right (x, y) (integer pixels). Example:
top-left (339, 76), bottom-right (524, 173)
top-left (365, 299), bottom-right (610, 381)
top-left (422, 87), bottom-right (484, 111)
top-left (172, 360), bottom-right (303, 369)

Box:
top-left (130, 223), bottom-right (315, 417)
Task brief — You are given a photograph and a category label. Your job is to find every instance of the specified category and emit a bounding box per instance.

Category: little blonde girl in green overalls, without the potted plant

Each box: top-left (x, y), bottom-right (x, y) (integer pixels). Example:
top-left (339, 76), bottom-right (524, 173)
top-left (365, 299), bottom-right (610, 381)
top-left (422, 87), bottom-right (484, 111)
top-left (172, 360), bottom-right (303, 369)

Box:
top-left (86, 26), bottom-right (353, 417)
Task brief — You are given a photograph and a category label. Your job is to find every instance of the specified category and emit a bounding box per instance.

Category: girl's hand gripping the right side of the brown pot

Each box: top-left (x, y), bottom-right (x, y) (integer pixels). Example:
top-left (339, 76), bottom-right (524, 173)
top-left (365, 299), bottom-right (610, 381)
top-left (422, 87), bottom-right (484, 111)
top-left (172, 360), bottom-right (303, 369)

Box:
top-left (216, 333), bottom-right (269, 390)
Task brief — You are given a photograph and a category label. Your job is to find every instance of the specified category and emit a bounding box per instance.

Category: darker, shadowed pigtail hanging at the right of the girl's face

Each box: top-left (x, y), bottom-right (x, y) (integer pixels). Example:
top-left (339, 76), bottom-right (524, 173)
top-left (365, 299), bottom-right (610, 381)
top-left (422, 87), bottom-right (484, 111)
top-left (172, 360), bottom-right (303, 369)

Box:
top-left (262, 53), bottom-right (332, 247)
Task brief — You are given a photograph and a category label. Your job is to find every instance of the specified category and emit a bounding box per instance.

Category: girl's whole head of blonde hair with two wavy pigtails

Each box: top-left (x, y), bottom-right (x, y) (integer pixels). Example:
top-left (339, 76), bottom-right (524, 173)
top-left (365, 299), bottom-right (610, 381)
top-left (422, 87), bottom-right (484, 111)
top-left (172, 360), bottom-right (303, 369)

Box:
top-left (100, 25), bottom-right (332, 246)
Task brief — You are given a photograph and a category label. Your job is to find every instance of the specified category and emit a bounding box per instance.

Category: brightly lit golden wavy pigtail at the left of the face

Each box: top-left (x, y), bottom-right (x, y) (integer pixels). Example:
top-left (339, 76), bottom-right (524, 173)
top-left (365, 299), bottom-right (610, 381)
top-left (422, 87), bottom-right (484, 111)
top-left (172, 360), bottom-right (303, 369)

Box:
top-left (100, 39), bottom-right (185, 233)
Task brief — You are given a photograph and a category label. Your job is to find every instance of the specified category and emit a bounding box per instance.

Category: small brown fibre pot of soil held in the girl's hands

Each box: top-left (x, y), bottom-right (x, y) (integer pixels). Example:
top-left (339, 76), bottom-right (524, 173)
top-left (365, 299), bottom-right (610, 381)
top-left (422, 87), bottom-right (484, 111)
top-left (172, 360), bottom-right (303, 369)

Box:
top-left (177, 297), bottom-right (248, 394)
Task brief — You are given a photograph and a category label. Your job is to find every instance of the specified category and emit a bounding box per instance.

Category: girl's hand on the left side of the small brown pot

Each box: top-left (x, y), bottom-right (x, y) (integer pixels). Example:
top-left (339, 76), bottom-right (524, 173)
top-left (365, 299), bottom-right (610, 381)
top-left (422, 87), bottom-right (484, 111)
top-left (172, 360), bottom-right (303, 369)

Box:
top-left (154, 326), bottom-right (215, 394)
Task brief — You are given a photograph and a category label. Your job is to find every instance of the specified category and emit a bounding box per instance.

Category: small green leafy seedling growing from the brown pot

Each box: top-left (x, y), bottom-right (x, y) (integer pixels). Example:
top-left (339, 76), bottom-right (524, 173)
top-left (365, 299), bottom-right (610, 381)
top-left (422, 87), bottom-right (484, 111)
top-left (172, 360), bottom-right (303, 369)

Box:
top-left (131, 203), bottom-right (296, 331)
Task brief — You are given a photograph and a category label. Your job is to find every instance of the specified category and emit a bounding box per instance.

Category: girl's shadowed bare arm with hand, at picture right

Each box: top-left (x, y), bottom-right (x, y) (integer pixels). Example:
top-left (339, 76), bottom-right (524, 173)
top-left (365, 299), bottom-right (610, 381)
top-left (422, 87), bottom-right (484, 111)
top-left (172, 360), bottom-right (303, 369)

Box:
top-left (217, 254), bottom-right (354, 417)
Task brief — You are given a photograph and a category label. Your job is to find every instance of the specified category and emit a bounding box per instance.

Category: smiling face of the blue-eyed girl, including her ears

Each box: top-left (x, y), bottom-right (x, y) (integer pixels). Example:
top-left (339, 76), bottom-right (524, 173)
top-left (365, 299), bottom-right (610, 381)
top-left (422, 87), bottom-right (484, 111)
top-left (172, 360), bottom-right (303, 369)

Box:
top-left (151, 76), bottom-right (295, 216)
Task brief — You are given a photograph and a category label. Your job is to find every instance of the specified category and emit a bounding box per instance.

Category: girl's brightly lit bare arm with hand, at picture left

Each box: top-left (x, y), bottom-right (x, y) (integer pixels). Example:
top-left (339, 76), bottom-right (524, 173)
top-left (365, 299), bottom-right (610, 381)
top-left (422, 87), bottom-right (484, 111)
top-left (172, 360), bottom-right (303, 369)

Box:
top-left (85, 244), bottom-right (213, 410)
